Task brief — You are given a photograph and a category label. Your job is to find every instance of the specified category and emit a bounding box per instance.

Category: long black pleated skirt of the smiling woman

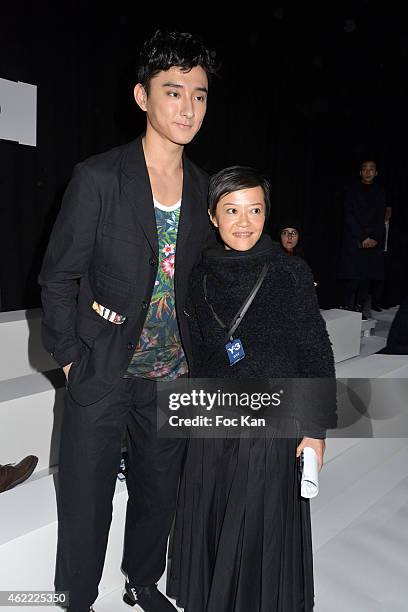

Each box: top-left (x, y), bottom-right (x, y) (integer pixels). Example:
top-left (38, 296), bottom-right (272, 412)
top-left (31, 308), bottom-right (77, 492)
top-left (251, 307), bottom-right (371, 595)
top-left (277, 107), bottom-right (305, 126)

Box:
top-left (167, 428), bottom-right (314, 612)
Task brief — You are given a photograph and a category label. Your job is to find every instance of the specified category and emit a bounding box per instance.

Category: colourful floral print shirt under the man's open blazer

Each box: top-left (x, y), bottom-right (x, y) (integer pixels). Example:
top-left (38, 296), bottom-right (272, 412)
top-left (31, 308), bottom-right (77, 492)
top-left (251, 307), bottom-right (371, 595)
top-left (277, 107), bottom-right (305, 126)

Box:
top-left (126, 202), bottom-right (188, 380)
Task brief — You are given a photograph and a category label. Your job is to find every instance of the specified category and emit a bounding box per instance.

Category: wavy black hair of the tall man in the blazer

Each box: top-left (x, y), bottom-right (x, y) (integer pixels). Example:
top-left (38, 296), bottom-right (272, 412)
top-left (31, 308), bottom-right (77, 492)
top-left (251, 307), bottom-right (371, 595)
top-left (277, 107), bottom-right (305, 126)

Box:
top-left (137, 30), bottom-right (216, 94)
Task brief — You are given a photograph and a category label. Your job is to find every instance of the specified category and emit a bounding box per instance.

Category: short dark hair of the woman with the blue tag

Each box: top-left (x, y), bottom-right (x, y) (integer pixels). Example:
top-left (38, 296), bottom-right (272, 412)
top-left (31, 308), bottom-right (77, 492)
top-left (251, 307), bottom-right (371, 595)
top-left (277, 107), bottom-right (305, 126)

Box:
top-left (208, 166), bottom-right (271, 218)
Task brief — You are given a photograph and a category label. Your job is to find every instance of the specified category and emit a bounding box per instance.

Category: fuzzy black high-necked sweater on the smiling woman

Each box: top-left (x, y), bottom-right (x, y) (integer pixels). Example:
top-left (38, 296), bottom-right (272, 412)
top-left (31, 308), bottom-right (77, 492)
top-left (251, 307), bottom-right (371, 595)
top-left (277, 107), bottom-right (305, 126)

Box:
top-left (187, 236), bottom-right (336, 437)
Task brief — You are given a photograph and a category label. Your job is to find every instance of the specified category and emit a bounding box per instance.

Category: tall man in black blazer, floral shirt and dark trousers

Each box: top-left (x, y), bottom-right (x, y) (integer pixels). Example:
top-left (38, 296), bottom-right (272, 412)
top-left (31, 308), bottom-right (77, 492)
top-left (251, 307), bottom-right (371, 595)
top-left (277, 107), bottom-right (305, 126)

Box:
top-left (39, 31), bottom-right (214, 612)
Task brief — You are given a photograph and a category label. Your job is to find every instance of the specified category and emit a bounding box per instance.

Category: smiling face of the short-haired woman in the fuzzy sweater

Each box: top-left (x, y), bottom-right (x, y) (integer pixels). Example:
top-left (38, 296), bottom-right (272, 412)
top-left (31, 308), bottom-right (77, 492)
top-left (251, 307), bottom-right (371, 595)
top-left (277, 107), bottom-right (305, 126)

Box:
top-left (209, 186), bottom-right (266, 251)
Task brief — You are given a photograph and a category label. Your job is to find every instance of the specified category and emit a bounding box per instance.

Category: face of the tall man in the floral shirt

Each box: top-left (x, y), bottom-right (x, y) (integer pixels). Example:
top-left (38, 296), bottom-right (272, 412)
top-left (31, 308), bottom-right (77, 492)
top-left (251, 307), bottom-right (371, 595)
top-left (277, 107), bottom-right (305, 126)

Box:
top-left (135, 66), bottom-right (208, 145)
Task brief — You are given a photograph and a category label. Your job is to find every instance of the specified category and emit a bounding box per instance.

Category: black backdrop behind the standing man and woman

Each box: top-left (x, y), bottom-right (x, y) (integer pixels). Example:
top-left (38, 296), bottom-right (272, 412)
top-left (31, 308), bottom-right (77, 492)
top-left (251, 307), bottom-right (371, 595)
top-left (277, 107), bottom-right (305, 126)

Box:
top-left (0, 0), bottom-right (408, 310)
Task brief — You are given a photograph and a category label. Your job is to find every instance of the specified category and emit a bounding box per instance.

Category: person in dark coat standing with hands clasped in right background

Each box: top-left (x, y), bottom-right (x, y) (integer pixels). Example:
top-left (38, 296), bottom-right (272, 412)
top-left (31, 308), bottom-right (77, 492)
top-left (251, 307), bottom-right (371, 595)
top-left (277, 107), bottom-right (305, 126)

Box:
top-left (337, 160), bottom-right (386, 316)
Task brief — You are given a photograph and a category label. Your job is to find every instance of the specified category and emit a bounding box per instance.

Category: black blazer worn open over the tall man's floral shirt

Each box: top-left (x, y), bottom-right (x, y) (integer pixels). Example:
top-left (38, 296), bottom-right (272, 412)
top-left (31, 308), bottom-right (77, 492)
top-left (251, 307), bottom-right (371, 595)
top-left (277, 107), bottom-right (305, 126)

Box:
top-left (39, 137), bottom-right (215, 406)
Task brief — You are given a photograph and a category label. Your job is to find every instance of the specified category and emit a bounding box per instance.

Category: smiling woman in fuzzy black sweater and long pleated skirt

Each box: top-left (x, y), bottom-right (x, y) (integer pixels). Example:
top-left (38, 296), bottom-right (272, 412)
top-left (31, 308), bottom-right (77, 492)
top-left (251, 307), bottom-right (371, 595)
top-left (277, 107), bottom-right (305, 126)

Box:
top-left (168, 167), bottom-right (336, 612)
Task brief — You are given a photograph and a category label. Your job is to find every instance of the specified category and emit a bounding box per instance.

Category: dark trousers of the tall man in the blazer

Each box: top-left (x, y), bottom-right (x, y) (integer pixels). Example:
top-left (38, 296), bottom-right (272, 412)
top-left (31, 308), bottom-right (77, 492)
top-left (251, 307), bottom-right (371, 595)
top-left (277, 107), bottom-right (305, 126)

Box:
top-left (55, 379), bottom-right (185, 608)
